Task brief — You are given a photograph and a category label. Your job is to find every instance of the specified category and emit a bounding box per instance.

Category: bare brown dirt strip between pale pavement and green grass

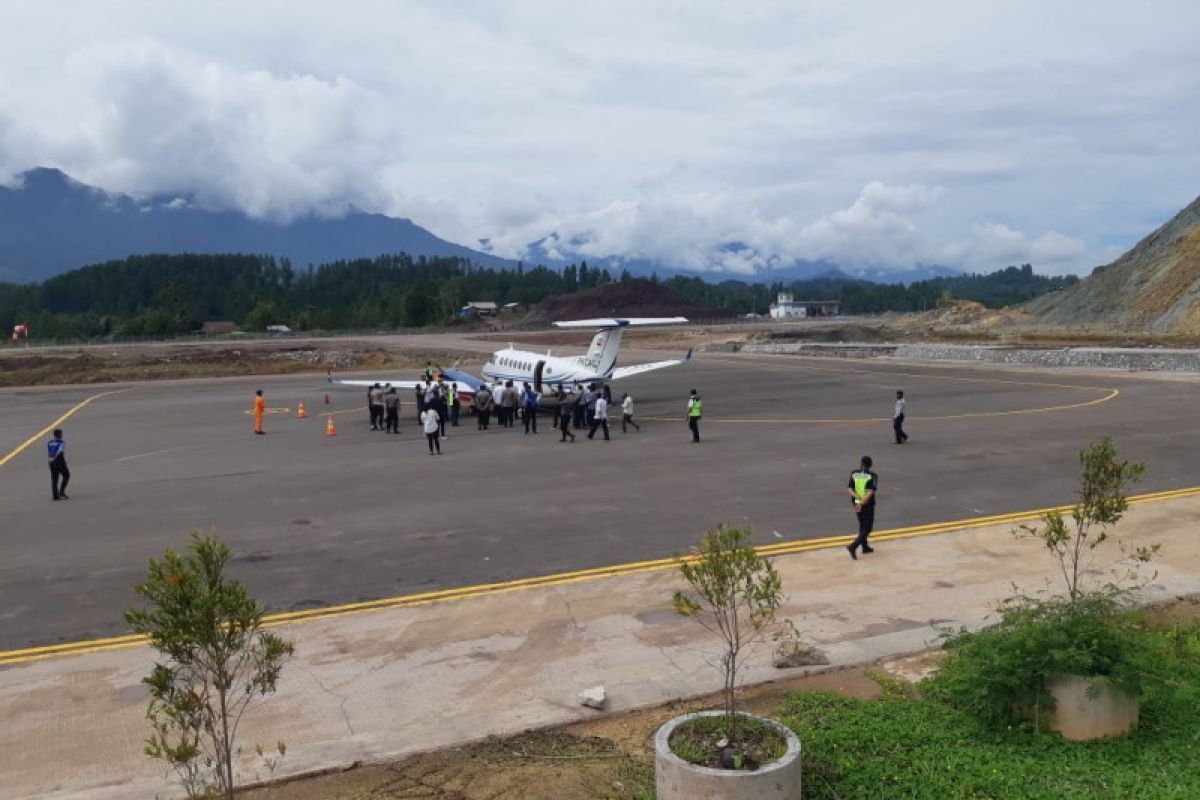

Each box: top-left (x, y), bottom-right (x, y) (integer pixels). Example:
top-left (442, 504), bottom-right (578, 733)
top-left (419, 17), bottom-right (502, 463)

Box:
top-left (240, 595), bottom-right (1200, 800)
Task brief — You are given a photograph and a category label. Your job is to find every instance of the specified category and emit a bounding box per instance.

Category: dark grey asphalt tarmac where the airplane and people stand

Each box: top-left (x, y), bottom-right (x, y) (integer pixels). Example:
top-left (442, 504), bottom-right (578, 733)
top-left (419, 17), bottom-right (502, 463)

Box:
top-left (0, 354), bottom-right (1200, 649)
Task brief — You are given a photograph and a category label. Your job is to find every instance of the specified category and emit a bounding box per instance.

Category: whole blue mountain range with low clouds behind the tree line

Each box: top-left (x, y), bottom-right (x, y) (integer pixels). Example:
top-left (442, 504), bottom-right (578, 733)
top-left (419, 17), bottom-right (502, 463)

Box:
top-left (0, 168), bottom-right (956, 282)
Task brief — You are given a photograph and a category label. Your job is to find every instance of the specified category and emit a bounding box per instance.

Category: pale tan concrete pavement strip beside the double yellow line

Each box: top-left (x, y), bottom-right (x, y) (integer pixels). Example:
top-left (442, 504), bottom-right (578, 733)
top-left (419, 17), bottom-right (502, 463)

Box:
top-left (0, 497), bottom-right (1200, 800)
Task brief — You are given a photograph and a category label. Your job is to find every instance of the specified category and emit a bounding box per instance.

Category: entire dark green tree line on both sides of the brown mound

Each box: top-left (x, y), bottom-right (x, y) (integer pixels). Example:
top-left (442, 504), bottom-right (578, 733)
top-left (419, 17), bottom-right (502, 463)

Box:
top-left (0, 254), bottom-right (1076, 339)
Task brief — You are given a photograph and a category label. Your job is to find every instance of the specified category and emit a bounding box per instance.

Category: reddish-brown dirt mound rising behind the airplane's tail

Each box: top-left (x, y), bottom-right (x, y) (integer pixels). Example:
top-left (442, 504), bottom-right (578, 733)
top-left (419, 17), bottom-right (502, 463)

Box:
top-left (528, 279), bottom-right (724, 323)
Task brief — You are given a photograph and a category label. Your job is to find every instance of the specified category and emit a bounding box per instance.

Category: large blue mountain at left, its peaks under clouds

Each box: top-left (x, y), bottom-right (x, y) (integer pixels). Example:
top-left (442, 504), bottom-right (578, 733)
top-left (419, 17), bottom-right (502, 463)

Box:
top-left (0, 168), bottom-right (514, 282)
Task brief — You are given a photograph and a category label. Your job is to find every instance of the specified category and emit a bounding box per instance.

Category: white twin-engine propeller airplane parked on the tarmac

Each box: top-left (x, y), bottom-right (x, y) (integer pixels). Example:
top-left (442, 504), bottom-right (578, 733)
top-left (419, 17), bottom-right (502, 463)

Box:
top-left (330, 317), bottom-right (691, 399)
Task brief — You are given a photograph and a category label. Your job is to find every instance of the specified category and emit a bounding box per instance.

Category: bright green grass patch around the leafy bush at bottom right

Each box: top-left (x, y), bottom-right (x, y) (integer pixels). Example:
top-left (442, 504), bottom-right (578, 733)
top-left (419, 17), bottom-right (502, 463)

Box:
top-left (780, 624), bottom-right (1200, 800)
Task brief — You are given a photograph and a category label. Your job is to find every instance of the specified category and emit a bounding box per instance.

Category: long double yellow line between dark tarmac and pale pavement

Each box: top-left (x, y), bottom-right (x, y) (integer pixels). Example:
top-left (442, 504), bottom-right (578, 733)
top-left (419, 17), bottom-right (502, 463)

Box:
top-left (0, 486), bottom-right (1200, 667)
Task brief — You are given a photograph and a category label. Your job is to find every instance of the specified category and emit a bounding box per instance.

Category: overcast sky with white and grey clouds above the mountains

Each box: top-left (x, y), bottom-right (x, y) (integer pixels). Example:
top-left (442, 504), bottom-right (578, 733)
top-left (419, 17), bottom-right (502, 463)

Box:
top-left (0, 0), bottom-right (1200, 272)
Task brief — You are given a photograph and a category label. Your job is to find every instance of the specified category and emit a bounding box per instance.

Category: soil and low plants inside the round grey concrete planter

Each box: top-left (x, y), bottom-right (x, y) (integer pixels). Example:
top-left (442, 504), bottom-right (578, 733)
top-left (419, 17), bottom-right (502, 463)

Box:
top-left (667, 715), bottom-right (787, 770)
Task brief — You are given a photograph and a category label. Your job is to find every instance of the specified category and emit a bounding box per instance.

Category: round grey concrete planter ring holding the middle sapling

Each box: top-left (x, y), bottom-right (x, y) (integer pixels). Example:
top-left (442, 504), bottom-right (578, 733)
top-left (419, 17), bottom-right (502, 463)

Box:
top-left (654, 711), bottom-right (800, 800)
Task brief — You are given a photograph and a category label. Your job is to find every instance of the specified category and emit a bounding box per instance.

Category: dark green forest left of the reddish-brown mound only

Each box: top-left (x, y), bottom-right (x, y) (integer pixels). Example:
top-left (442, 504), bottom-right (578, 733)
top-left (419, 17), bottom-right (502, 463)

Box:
top-left (0, 254), bottom-right (613, 339)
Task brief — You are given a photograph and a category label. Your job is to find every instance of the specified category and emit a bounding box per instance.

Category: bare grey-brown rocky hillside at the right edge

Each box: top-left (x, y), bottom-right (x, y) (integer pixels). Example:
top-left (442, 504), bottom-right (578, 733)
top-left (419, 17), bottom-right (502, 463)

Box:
top-left (1026, 198), bottom-right (1200, 333)
